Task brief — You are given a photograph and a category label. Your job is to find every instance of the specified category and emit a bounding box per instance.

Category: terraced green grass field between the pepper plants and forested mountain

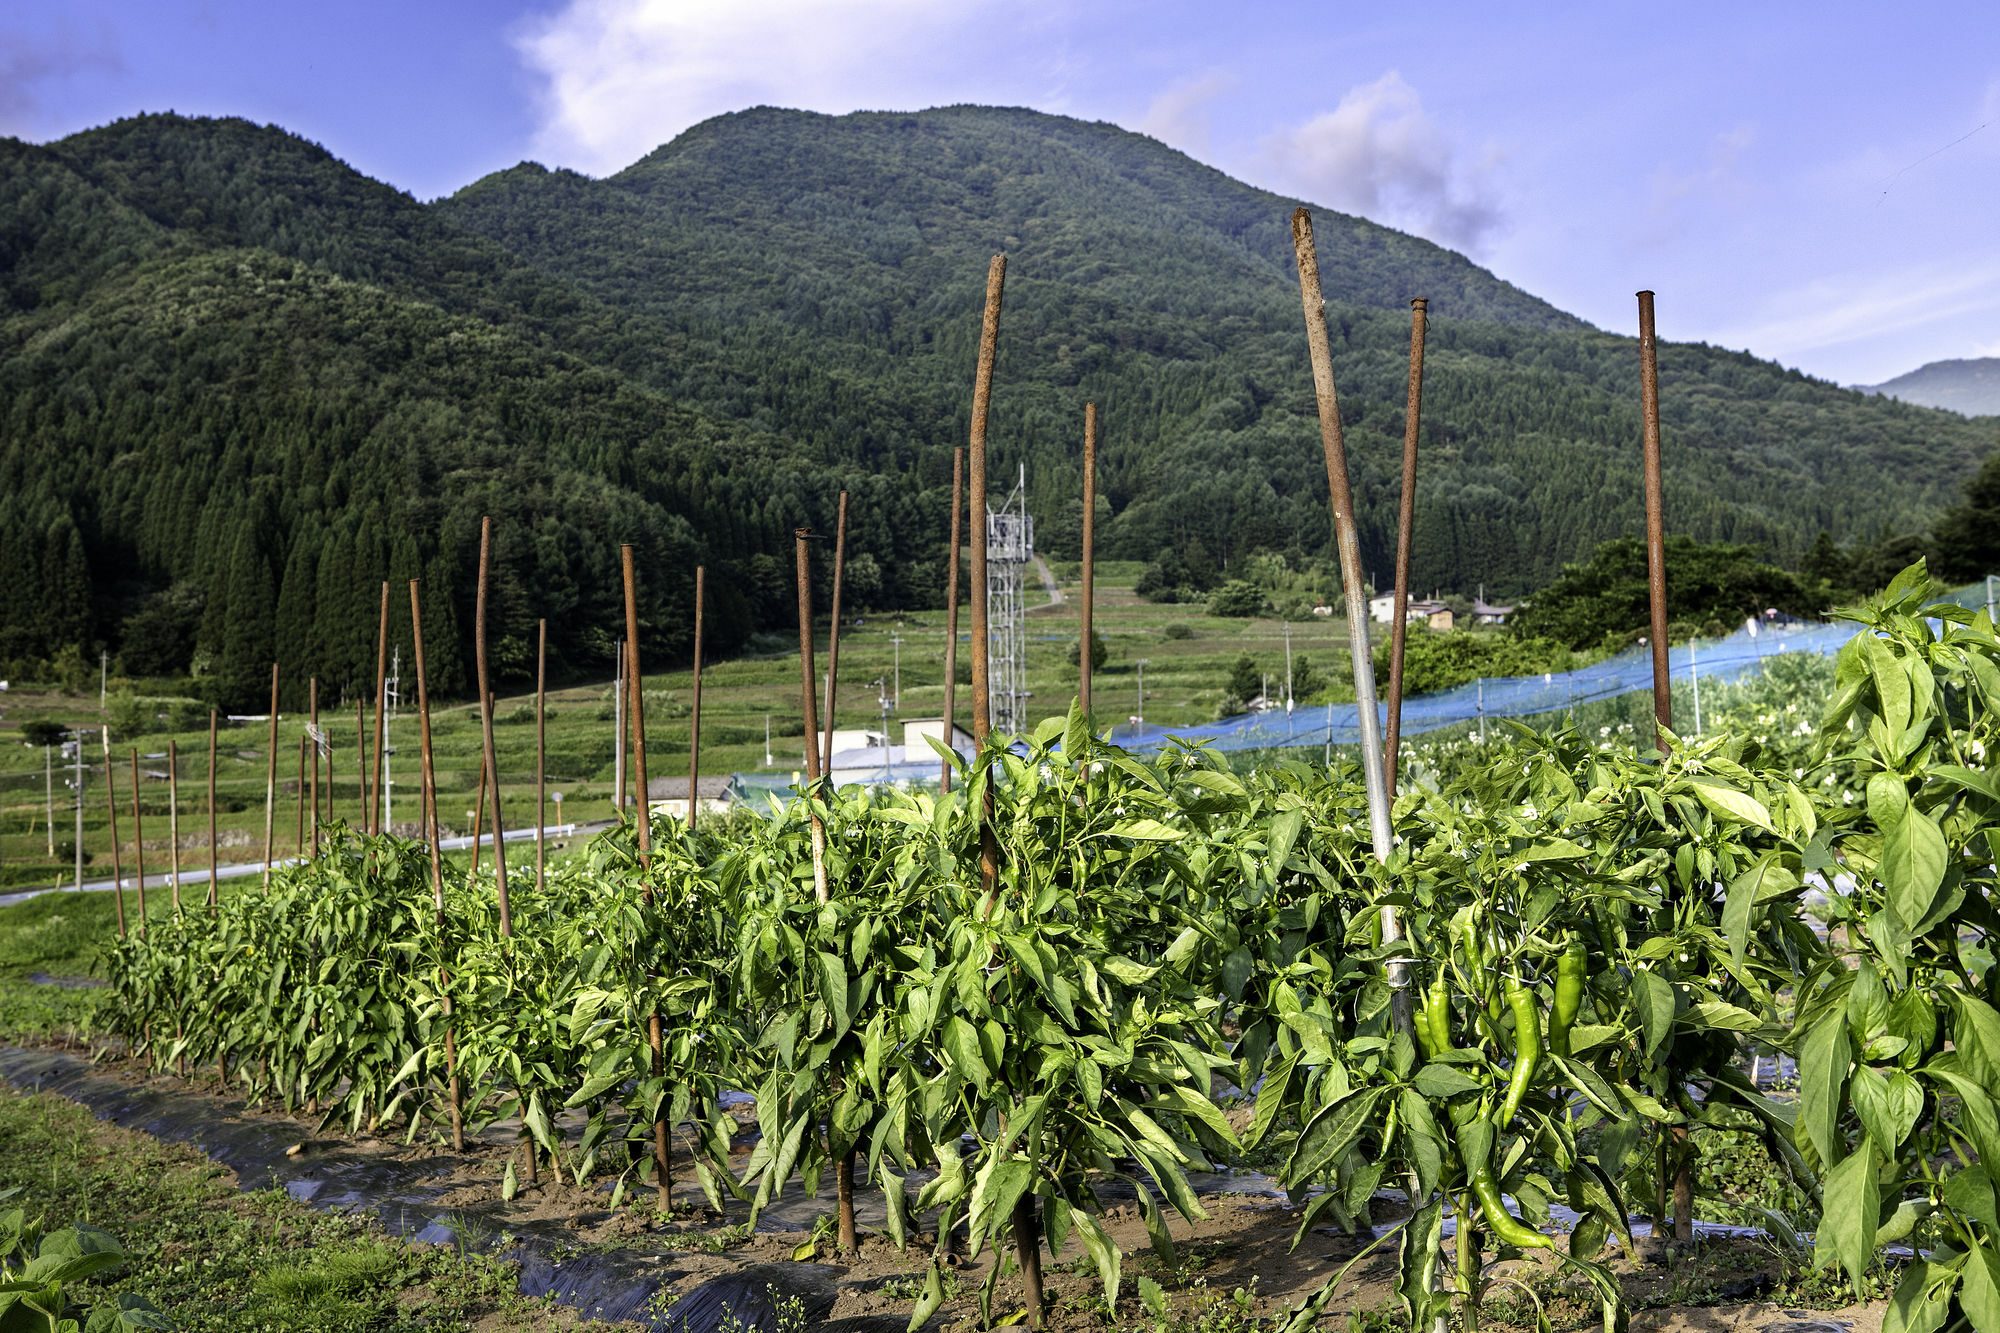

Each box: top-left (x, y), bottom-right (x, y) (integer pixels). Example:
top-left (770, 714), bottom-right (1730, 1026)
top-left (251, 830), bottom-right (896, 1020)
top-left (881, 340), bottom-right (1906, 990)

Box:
top-left (0, 562), bottom-right (1400, 889)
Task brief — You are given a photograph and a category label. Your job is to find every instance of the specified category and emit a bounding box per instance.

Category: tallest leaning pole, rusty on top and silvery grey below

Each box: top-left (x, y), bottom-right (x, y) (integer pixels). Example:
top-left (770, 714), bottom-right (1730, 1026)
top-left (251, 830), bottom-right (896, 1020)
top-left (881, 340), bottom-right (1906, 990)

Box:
top-left (1292, 208), bottom-right (1412, 1012)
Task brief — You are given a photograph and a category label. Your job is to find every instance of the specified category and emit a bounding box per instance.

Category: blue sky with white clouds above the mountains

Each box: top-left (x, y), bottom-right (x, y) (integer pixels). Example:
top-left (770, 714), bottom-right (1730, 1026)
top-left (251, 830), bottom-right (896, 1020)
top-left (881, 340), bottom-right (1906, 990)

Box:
top-left (0, 0), bottom-right (2000, 382)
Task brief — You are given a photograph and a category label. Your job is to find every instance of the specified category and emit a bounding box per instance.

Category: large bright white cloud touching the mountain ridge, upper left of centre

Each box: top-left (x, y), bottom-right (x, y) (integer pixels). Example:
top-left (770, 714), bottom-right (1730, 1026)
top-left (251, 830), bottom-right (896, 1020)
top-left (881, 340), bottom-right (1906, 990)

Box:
top-left (514, 0), bottom-right (1016, 172)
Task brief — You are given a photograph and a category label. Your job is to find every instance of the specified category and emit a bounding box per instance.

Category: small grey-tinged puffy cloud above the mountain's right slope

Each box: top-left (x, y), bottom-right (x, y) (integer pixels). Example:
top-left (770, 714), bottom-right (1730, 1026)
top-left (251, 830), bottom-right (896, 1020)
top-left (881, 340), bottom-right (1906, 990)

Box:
top-left (1264, 70), bottom-right (1500, 250)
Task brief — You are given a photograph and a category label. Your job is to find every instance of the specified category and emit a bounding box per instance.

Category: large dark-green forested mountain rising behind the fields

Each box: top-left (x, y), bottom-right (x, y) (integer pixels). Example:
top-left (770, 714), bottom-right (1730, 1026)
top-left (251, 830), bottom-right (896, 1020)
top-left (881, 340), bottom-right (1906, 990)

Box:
top-left (0, 108), bottom-right (1992, 707)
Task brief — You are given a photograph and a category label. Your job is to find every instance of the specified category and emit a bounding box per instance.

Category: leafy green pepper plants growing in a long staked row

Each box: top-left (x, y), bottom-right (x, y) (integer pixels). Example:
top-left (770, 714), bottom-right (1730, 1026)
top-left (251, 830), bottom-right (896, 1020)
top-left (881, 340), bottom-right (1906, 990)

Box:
top-left (112, 566), bottom-right (2000, 1333)
